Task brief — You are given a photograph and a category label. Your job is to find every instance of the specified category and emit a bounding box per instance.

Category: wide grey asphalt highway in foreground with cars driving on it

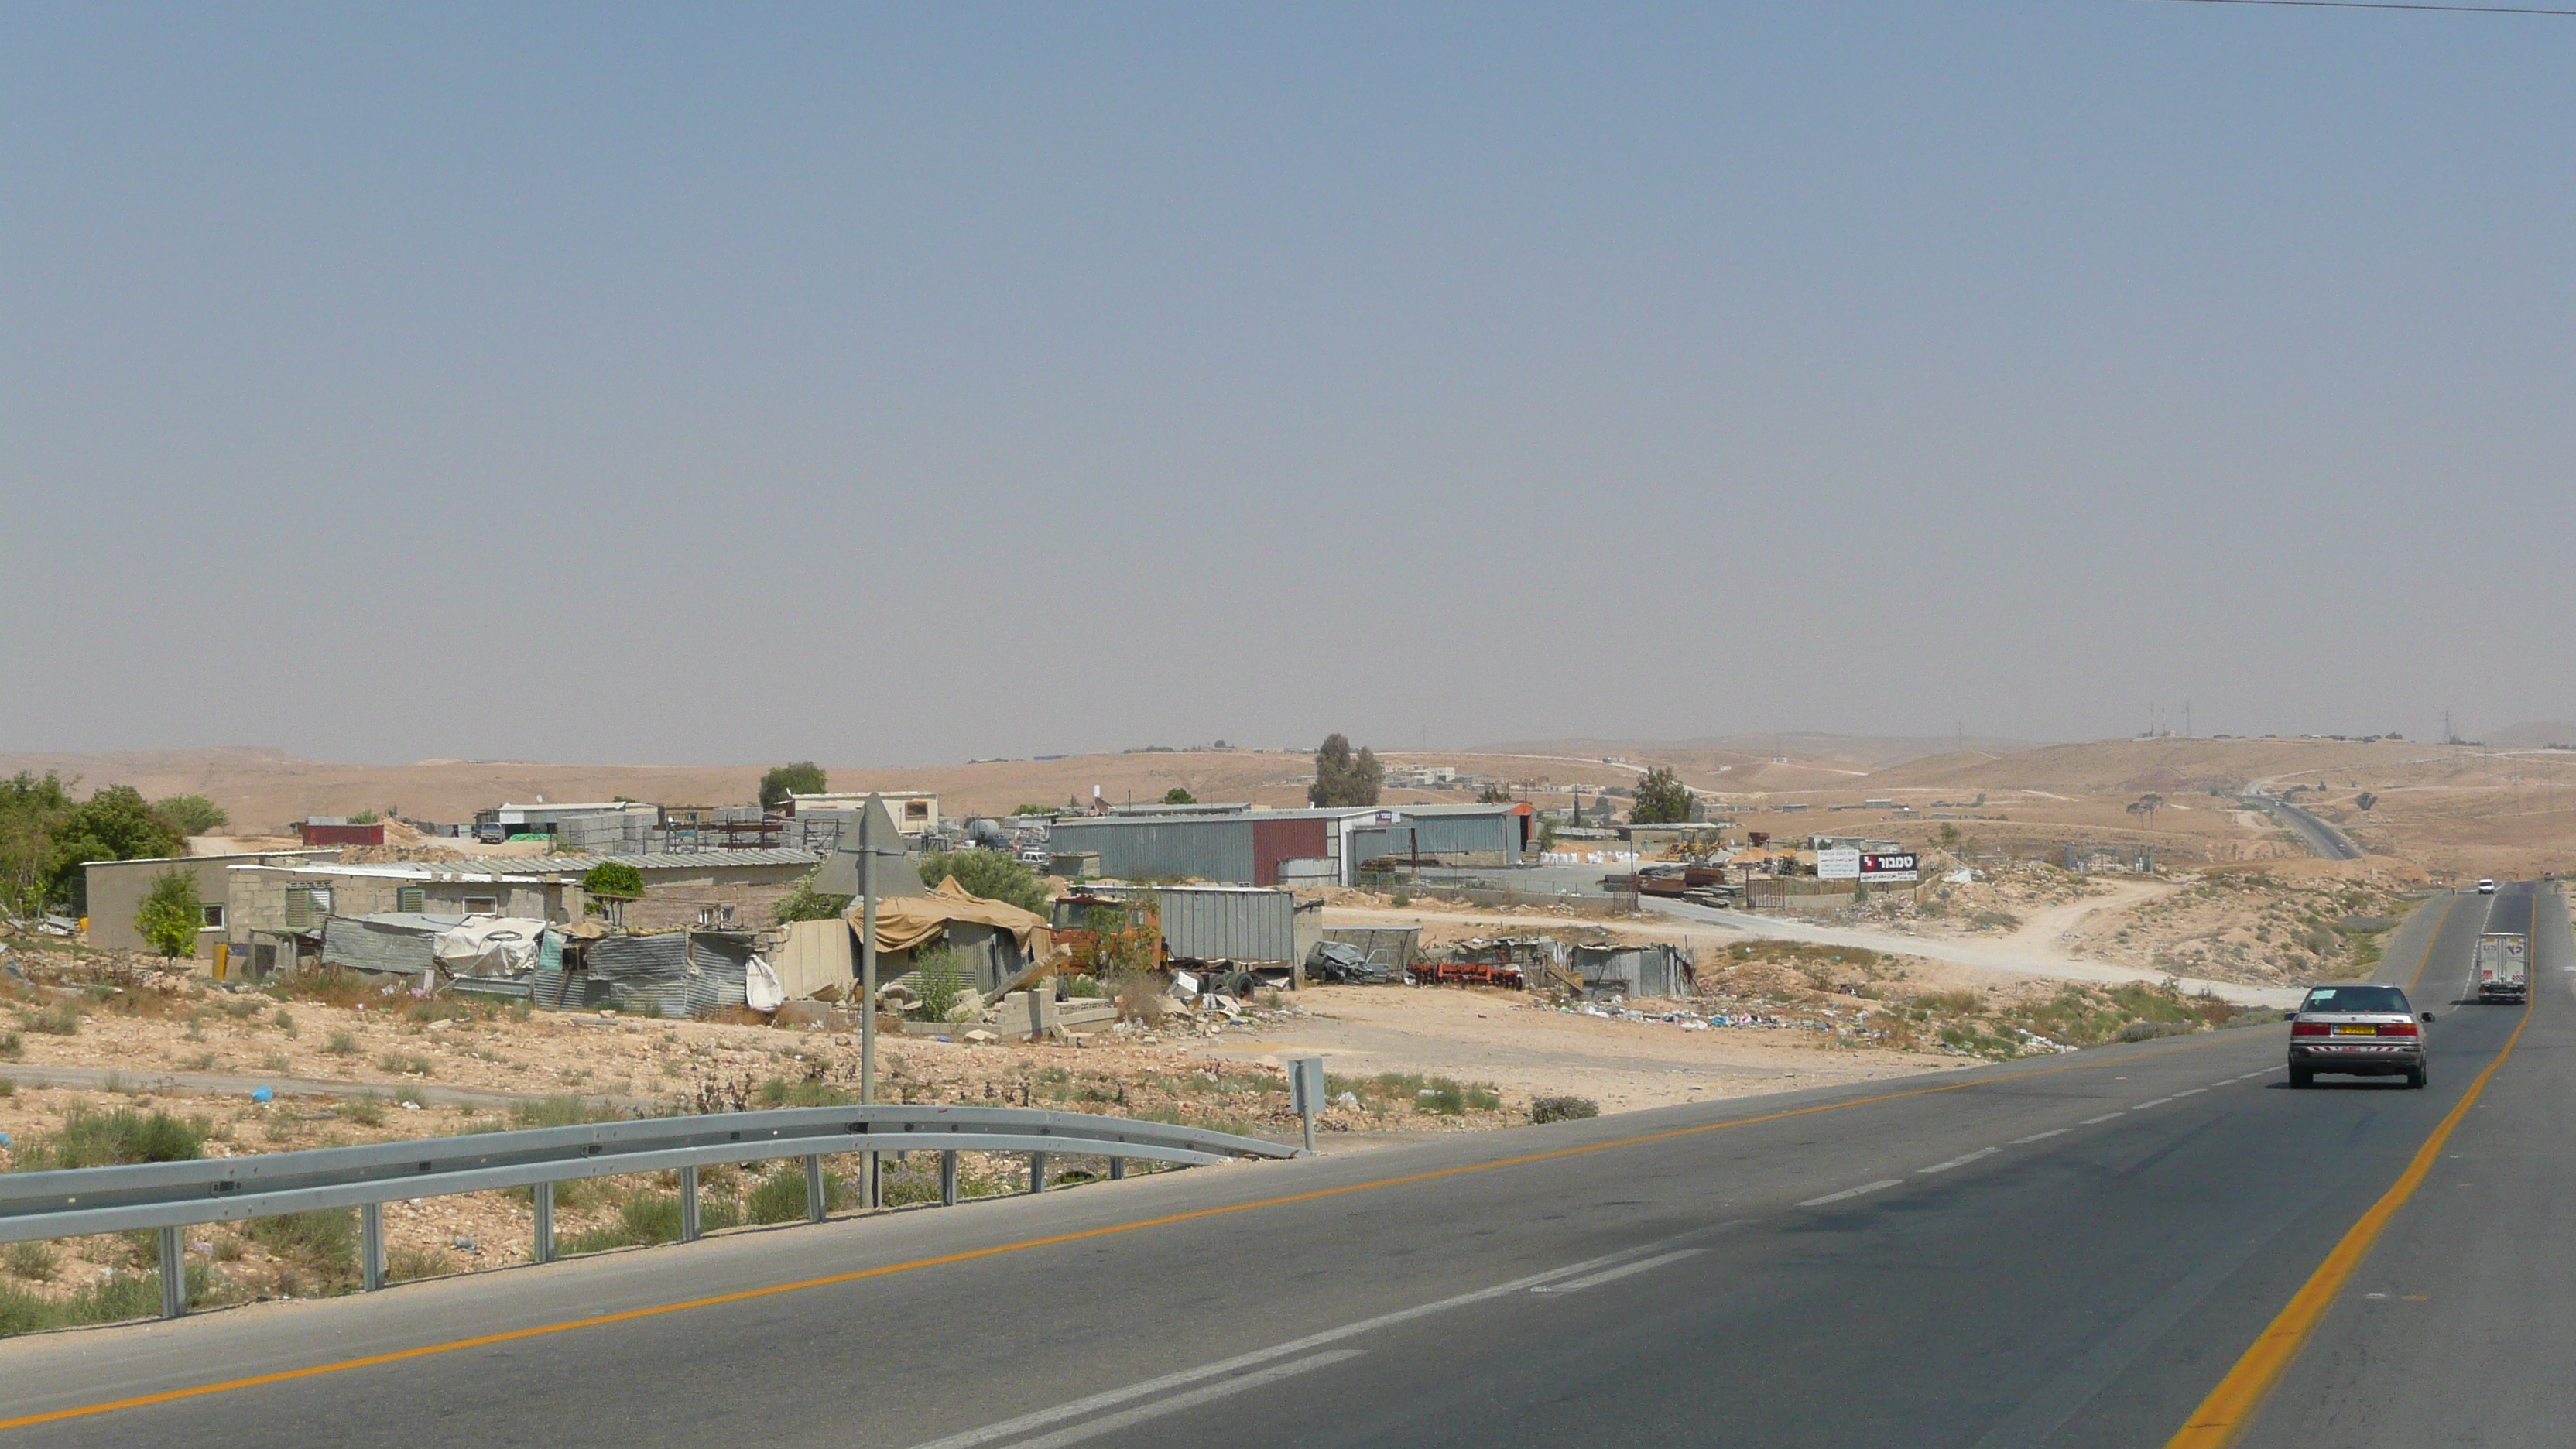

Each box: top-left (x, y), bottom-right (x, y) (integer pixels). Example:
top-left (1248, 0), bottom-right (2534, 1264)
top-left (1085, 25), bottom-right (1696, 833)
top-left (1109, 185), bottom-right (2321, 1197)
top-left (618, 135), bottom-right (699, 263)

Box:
top-left (0, 887), bottom-right (2576, 1449)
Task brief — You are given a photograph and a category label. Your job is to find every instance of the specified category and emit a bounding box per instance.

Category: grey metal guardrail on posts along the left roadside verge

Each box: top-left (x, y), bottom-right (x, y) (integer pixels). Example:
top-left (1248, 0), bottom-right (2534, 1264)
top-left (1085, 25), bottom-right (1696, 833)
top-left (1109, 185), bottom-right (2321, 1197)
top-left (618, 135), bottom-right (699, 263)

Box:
top-left (0, 1104), bottom-right (1298, 1317)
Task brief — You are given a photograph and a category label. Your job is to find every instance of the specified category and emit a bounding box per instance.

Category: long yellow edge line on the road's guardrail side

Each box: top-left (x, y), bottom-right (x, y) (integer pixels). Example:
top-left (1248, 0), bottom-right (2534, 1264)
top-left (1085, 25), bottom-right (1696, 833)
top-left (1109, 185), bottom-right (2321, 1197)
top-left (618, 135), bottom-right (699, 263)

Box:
top-left (0, 1031), bottom-right (2233, 1428)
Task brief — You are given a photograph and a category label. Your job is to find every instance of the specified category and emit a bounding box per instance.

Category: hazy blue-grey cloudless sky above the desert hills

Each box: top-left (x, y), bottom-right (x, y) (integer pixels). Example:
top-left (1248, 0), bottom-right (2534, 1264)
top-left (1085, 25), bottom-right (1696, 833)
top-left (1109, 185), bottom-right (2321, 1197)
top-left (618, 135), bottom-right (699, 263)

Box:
top-left (0, 0), bottom-right (2576, 763)
